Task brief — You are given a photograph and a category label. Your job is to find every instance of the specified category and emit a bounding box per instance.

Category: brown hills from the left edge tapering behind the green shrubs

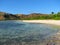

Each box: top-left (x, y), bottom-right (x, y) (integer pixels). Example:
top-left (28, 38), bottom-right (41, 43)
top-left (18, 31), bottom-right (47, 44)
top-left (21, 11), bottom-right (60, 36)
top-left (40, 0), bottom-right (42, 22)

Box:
top-left (0, 12), bottom-right (47, 20)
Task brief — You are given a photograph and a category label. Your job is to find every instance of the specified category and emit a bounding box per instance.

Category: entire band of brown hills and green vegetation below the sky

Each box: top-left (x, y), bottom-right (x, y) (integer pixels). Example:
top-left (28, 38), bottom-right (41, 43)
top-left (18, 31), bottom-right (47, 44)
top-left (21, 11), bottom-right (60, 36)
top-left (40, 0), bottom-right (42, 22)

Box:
top-left (0, 12), bottom-right (60, 20)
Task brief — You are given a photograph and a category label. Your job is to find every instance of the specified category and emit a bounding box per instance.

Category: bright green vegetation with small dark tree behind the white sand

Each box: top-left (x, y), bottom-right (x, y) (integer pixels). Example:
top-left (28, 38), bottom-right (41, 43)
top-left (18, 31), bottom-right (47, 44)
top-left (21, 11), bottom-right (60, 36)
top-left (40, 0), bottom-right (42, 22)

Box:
top-left (20, 12), bottom-right (60, 20)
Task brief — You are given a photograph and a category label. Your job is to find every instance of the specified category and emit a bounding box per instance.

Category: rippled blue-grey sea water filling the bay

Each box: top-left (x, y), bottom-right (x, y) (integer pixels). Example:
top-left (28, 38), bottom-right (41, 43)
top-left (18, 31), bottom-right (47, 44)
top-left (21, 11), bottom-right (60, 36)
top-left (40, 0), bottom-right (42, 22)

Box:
top-left (0, 20), bottom-right (60, 45)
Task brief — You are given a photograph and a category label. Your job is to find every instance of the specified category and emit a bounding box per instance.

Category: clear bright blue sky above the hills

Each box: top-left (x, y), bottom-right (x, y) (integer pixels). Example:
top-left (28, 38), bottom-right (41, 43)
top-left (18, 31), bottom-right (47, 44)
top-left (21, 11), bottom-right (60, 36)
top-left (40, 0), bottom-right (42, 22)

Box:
top-left (0, 0), bottom-right (60, 14)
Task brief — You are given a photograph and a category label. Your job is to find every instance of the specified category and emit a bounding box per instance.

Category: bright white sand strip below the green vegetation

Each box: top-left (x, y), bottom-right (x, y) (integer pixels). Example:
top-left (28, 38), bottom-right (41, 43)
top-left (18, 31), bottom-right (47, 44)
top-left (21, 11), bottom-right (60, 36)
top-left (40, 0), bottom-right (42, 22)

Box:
top-left (22, 20), bottom-right (60, 25)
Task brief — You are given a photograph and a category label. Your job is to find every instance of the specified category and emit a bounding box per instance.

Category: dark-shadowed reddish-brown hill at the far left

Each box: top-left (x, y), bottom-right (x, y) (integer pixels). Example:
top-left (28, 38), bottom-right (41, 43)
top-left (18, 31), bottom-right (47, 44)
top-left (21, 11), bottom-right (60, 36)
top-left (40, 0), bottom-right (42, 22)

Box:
top-left (0, 12), bottom-right (19, 20)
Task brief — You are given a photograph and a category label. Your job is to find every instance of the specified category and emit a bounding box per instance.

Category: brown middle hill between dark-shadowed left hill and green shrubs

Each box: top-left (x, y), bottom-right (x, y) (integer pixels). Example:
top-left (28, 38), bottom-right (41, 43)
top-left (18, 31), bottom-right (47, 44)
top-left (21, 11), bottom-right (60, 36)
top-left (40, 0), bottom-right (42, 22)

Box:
top-left (16, 13), bottom-right (48, 20)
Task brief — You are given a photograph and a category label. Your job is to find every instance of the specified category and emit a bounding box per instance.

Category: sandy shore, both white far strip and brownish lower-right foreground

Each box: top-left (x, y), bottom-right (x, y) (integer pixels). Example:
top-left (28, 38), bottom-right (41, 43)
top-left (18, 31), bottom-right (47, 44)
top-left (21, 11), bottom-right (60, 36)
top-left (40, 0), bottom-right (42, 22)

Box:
top-left (23, 20), bottom-right (60, 45)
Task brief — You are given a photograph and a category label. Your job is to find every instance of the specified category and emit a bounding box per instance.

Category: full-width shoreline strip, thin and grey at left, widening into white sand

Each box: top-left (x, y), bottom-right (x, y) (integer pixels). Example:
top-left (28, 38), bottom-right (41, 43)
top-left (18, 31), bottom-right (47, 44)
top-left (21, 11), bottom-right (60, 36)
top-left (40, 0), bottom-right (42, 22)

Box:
top-left (1, 20), bottom-right (60, 26)
